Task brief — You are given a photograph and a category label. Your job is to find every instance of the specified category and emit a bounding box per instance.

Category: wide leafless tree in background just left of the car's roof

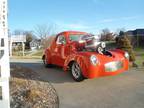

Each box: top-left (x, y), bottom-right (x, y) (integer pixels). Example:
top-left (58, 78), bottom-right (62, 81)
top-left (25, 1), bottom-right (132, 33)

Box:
top-left (35, 24), bottom-right (57, 48)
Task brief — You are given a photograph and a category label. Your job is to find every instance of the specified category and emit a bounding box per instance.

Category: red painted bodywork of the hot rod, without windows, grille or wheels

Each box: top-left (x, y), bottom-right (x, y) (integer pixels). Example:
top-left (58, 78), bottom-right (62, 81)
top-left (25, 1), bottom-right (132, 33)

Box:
top-left (44, 31), bottom-right (129, 78)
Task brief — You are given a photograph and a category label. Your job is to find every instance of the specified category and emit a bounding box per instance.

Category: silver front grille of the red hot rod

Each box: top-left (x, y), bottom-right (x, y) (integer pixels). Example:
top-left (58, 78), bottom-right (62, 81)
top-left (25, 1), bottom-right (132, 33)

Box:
top-left (105, 61), bottom-right (123, 72)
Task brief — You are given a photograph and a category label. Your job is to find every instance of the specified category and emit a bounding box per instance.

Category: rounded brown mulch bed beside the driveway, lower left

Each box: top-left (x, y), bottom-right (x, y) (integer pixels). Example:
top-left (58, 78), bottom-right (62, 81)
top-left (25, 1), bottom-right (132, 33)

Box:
top-left (10, 65), bottom-right (59, 108)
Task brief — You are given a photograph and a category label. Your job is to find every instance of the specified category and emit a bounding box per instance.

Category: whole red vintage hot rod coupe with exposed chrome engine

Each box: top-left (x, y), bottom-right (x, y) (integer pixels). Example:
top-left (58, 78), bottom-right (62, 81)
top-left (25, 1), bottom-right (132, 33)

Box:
top-left (42, 31), bottom-right (129, 81)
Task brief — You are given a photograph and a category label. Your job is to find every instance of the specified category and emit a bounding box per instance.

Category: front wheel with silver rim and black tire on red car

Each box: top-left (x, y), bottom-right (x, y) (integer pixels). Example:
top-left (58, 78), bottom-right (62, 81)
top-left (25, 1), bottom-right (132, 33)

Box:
top-left (70, 62), bottom-right (85, 82)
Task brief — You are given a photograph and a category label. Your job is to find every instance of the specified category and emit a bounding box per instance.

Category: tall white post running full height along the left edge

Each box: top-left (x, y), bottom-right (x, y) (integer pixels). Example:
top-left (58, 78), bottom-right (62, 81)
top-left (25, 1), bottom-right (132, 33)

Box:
top-left (0, 0), bottom-right (10, 108)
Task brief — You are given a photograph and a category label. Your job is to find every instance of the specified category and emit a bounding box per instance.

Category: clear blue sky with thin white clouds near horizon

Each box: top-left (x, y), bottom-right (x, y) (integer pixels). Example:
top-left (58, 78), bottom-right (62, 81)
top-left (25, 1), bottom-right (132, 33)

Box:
top-left (8, 0), bottom-right (144, 33)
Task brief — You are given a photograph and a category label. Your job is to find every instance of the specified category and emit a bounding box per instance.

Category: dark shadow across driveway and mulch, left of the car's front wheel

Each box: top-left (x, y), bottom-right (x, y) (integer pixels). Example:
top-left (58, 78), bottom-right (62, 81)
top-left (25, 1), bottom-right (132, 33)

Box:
top-left (11, 62), bottom-right (75, 83)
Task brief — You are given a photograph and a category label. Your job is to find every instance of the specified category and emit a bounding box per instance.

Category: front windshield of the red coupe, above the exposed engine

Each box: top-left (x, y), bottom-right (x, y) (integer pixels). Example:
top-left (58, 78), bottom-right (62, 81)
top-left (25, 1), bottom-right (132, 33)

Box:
top-left (69, 34), bottom-right (93, 41)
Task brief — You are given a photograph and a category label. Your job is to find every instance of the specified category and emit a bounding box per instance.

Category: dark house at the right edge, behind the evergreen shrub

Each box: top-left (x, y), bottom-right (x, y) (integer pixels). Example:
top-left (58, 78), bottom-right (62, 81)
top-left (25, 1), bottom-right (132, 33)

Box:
top-left (126, 29), bottom-right (144, 47)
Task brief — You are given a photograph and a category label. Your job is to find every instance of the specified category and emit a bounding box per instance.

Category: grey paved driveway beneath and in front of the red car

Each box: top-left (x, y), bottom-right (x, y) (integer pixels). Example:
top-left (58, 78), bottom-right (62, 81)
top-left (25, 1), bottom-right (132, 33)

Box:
top-left (11, 59), bottom-right (144, 108)
